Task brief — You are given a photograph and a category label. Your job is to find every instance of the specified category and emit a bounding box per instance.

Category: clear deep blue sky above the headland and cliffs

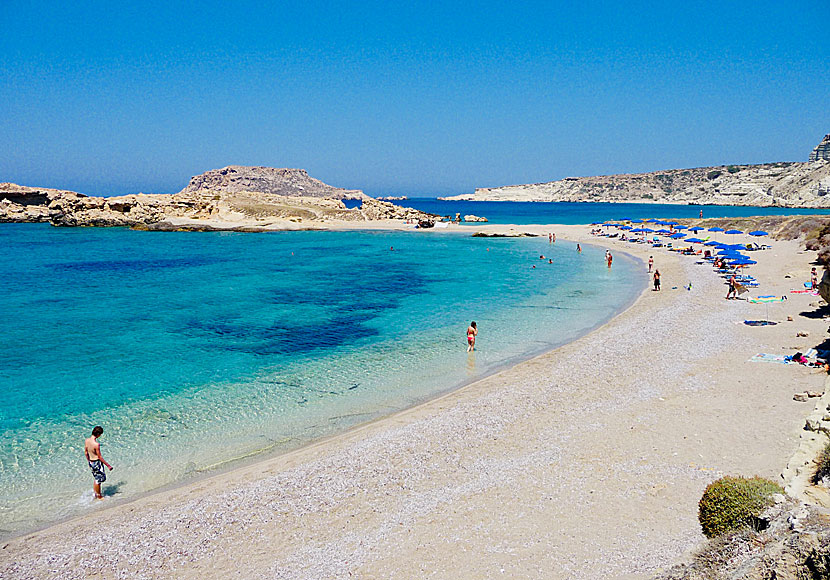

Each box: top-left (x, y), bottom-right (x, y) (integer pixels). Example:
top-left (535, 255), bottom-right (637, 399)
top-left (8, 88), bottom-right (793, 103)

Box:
top-left (0, 0), bottom-right (830, 195)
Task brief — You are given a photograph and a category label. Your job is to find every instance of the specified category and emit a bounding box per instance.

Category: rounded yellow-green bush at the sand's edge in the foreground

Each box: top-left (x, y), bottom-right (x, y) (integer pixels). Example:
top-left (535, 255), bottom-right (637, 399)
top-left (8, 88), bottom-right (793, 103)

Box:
top-left (697, 477), bottom-right (784, 538)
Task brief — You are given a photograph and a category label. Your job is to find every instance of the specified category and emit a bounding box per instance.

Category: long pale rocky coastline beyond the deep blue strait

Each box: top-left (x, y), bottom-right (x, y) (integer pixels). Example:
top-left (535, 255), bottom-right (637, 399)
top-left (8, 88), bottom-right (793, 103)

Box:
top-left (441, 161), bottom-right (830, 207)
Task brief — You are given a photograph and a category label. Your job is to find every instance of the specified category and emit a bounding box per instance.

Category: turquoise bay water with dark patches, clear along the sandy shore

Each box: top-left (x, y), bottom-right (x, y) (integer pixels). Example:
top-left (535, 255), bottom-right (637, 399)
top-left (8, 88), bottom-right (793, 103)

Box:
top-left (0, 224), bottom-right (645, 535)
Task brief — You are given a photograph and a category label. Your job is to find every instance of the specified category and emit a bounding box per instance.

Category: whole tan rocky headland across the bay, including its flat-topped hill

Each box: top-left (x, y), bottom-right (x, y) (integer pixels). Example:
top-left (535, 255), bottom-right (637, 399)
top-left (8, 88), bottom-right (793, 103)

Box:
top-left (0, 166), bottom-right (436, 231)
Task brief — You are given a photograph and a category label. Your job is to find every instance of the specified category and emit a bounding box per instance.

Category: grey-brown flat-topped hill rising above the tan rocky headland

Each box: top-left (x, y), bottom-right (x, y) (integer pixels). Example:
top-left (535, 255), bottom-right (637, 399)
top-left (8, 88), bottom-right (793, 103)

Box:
top-left (179, 165), bottom-right (366, 199)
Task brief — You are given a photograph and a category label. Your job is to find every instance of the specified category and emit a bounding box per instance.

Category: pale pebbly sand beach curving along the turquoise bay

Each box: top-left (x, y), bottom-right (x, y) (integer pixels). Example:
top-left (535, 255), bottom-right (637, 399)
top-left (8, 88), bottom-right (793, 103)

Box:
top-left (0, 225), bottom-right (827, 579)
